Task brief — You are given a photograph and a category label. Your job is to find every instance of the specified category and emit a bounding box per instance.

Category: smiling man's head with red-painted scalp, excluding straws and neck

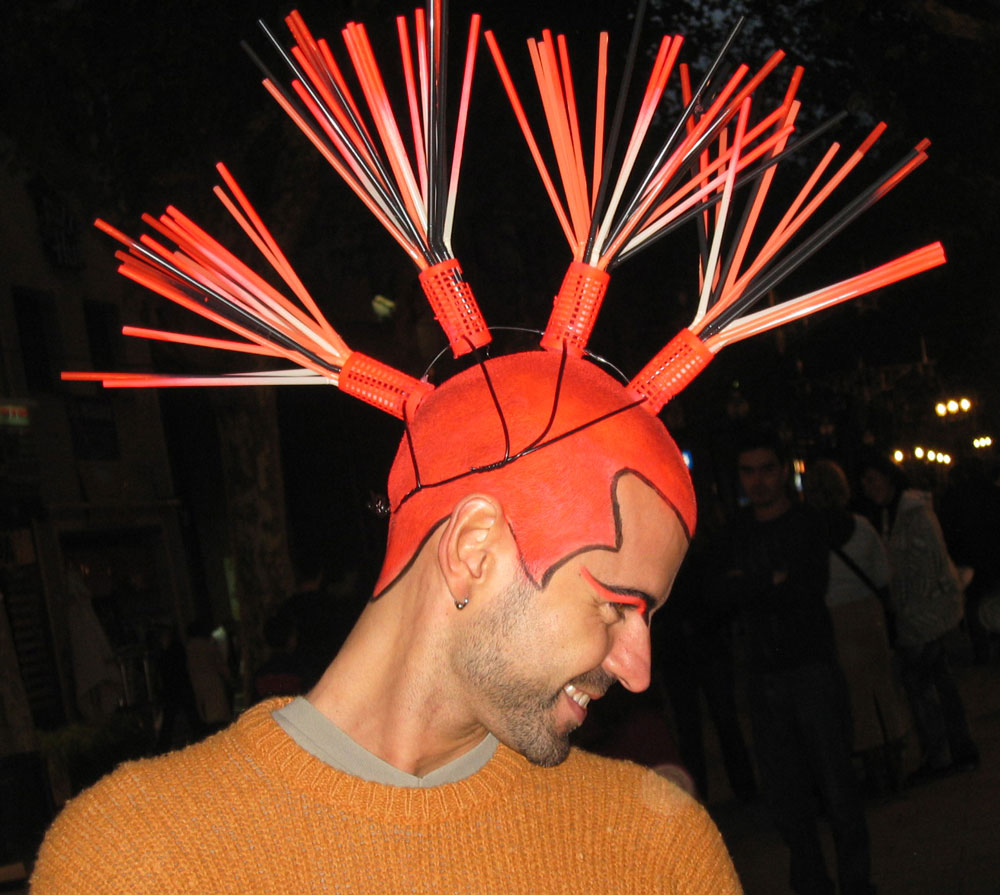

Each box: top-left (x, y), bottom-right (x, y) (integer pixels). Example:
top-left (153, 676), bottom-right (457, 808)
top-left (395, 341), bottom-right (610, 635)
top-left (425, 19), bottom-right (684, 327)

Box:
top-left (362, 352), bottom-right (695, 765)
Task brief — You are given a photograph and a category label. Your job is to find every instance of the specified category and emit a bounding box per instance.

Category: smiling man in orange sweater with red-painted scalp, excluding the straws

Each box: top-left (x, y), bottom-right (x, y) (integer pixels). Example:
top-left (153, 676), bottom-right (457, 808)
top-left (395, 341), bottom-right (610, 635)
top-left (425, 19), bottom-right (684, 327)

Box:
top-left (32, 351), bottom-right (739, 895)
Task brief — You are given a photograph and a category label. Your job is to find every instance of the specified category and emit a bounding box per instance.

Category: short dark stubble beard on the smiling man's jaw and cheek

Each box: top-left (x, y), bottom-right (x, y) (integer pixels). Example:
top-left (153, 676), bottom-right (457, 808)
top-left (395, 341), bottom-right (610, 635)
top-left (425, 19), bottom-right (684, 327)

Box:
top-left (454, 578), bottom-right (613, 768)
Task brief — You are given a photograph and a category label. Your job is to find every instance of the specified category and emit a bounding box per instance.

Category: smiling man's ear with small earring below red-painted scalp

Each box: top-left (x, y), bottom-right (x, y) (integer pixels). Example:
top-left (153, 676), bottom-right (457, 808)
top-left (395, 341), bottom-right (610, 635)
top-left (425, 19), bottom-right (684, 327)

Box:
top-left (438, 494), bottom-right (517, 602)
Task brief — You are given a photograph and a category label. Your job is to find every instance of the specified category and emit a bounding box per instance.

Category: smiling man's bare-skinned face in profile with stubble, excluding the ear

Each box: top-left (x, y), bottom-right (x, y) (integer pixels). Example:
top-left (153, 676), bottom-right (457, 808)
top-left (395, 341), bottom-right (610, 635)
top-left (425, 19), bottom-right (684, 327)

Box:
top-left (452, 476), bottom-right (687, 767)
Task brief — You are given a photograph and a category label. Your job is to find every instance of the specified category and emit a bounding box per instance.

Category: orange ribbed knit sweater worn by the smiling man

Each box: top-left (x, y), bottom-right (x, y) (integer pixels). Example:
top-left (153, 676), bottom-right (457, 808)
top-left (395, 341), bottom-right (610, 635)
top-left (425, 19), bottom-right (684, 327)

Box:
top-left (31, 699), bottom-right (740, 895)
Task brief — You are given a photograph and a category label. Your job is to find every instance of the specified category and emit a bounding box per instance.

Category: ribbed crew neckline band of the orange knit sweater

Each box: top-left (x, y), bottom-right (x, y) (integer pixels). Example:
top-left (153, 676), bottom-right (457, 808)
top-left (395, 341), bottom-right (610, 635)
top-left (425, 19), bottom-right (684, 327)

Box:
top-left (229, 697), bottom-right (541, 823)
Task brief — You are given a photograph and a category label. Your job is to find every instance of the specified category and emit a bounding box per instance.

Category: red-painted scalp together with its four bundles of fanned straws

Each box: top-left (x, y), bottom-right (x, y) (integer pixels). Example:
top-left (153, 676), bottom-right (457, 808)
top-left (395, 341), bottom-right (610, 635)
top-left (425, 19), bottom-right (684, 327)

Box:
top-left (64, 0), bottom-right (944, 590)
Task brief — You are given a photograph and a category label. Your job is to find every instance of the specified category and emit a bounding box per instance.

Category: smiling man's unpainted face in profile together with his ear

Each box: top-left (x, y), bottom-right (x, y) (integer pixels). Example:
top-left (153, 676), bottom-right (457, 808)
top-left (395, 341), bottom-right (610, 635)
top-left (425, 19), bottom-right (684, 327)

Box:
top-left (442, 475), bottom-right (687, 766)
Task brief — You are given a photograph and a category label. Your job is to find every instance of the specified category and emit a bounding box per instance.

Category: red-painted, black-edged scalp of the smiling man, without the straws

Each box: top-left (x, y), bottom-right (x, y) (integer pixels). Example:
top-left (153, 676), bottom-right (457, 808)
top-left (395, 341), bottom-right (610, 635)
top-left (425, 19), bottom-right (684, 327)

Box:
top-left (375, 351), bottom-right (695, 596)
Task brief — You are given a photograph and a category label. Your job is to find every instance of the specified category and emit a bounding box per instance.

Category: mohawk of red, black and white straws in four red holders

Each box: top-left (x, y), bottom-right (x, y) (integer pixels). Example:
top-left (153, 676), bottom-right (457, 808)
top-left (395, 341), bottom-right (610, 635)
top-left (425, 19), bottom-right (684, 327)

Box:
top-left (64, 0), bottom-right (945, 419)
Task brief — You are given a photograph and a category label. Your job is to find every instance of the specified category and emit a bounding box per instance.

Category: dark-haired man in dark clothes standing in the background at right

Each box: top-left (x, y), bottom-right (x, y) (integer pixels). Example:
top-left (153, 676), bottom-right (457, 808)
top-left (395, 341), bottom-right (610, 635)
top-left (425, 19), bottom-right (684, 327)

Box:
top-left (717, 433), bottom-right (871, 895)
